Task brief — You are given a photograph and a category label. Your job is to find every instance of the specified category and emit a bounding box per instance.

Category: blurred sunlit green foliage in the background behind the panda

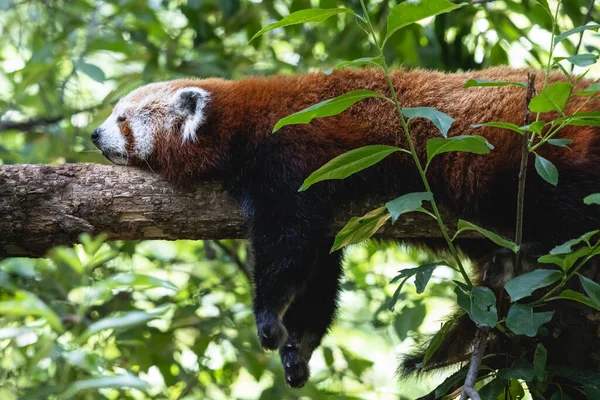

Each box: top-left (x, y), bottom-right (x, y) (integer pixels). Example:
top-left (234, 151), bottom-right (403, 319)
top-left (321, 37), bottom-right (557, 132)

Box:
top-left (0, 0), bottom-right (600, 400)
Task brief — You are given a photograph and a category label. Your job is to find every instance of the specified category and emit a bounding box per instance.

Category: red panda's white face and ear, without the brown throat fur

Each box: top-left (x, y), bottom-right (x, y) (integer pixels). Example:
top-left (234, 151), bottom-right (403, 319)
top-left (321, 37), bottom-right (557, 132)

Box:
top-left (92, 81), bottom-right (210, 166)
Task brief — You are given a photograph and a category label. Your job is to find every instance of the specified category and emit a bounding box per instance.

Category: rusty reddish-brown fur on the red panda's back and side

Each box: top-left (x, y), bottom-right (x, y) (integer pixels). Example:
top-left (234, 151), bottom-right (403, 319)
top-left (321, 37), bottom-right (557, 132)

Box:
top-left (145, 67), bottom-right (600, 206)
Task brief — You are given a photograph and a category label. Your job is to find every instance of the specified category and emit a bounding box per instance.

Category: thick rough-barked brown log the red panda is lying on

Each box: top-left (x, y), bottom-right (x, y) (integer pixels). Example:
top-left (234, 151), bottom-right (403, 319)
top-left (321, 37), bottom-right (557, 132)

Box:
top-left (0, 164), bottom-right (478, 257)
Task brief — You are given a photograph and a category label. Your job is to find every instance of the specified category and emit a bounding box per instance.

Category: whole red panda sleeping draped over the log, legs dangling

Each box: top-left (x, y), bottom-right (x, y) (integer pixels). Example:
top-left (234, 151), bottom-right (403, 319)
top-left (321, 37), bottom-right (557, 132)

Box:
top-left (92, 68), bottom-right (600, 387)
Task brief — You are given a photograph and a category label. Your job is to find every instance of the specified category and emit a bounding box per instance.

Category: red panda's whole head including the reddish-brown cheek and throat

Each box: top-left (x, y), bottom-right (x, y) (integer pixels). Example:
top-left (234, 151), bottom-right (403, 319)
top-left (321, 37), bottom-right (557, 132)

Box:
top-left (92, 80), bottom-right (222, 178)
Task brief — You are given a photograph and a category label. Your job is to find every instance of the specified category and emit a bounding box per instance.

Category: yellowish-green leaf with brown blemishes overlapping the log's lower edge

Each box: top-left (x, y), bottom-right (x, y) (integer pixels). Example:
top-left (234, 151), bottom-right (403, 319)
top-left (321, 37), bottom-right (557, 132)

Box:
top-left (331, 207), bottom-right (391, 252)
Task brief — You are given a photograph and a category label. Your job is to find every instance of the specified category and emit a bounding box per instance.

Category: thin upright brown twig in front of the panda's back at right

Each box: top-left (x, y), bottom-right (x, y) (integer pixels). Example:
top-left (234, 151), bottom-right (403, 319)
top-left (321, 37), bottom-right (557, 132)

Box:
top-left (515, 72), bottom-right (535, 268)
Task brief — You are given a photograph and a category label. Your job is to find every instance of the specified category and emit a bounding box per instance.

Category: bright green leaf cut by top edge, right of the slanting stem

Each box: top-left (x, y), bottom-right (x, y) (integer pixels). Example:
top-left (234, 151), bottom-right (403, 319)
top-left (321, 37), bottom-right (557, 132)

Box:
top-left (384, 0), bottom-right (463, 42)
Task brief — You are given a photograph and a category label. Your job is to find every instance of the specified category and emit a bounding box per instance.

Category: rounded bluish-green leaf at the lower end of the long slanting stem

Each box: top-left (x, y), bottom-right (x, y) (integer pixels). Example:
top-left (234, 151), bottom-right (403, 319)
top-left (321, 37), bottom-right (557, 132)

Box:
top-left (454, 286), bottom-right (498, 328)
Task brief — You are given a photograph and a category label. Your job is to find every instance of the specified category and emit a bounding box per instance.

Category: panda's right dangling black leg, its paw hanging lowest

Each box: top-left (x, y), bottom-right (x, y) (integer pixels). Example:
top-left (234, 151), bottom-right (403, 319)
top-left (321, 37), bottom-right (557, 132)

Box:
top-left (279, 240), bottom-right (342, 387)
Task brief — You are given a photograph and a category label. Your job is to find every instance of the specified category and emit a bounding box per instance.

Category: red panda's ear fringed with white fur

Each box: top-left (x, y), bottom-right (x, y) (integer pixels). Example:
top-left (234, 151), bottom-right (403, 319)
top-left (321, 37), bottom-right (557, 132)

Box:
top-left (173, 87), bottom-right (210, 143)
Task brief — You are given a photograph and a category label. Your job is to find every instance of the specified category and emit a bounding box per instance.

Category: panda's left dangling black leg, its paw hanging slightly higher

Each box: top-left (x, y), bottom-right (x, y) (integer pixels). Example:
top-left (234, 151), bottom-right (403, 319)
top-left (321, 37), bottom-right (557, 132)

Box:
top-left (251, 193), bottom-right (335, 350)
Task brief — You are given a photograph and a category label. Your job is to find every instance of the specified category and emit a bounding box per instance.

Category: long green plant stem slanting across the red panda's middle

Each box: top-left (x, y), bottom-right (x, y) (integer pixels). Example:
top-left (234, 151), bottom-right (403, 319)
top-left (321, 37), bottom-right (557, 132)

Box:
top-left (360, 0), bottom-right (473, 287)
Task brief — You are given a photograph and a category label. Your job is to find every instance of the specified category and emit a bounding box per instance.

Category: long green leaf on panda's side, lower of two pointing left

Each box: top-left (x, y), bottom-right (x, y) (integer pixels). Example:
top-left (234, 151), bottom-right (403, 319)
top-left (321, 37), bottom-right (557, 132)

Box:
top-left (298, 145), bottom-right (402, 192)
